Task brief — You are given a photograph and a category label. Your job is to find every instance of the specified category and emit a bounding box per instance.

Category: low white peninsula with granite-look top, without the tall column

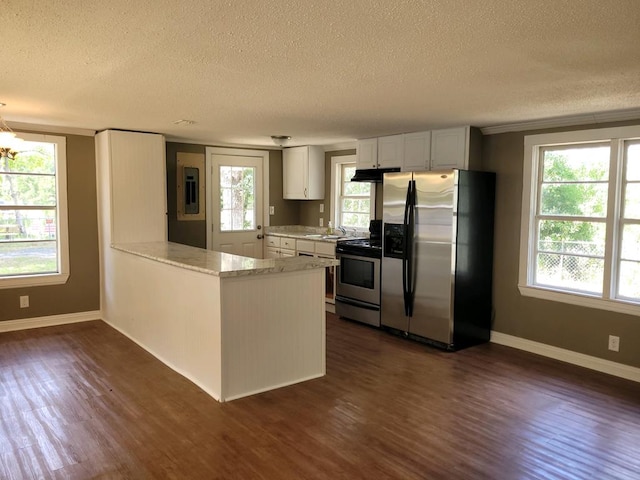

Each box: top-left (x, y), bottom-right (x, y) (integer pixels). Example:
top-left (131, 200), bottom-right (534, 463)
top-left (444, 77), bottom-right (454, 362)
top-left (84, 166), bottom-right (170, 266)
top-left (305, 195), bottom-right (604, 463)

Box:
top-left (103, 242), bottom-right (335, 401)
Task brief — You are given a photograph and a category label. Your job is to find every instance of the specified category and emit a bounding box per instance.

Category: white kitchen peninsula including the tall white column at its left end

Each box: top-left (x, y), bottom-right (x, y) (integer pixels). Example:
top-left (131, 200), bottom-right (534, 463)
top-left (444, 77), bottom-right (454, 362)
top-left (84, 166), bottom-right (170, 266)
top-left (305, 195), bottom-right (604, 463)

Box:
top-left (96, 130), bottom-right (336, 401)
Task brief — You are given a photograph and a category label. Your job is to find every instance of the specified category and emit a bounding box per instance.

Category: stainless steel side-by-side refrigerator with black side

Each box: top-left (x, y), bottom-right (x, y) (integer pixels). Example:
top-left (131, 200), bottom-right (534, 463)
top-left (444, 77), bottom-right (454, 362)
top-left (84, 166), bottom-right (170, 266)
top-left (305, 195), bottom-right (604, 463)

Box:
top-left (380, 170), bottom-right (495, 350)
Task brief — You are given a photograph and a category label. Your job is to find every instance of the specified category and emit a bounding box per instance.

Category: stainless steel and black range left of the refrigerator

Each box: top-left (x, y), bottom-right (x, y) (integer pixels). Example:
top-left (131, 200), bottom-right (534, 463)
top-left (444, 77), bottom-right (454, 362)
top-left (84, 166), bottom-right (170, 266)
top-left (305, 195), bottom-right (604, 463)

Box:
top-left (336, 221), bottom-right (382, 327)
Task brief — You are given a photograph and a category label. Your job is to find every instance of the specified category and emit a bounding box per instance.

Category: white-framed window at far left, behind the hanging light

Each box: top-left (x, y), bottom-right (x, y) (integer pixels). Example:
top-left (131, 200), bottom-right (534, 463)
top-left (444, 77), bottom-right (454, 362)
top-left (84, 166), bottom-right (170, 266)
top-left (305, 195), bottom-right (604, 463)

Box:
top-left (0, 134), bottom-right (69, 288)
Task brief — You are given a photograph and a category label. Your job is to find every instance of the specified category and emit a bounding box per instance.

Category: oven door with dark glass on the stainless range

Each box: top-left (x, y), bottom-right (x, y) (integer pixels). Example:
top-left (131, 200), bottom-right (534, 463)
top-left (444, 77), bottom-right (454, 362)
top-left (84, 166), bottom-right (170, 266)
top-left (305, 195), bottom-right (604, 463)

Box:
top-left (336, 253), bottom-right (380, 305)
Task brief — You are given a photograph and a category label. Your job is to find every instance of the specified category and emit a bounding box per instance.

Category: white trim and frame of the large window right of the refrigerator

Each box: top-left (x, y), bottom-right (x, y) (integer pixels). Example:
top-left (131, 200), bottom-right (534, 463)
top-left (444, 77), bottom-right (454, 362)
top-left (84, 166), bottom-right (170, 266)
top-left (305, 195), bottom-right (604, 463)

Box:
top-left (518, 126), bottom-right (640, 315)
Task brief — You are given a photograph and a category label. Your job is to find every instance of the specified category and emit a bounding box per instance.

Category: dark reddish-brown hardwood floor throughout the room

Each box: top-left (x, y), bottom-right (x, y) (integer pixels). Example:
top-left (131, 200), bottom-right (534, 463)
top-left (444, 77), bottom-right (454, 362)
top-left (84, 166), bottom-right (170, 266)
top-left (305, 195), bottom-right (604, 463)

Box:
top-left (0, 314), bottom-right (640, 480)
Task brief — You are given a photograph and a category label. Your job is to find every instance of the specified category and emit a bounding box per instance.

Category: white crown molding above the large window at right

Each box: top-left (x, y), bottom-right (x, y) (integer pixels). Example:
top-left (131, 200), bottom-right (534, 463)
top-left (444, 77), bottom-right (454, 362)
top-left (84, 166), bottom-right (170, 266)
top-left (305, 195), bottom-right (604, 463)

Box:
top-left (480, 108), bottom-right (640, 135)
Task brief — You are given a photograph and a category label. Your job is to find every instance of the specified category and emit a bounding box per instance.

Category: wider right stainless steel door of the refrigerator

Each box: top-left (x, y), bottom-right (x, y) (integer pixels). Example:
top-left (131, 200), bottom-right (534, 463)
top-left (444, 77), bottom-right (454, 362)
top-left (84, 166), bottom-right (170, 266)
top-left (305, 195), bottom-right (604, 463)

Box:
top-left (409, 170), bottom-right (457, 345)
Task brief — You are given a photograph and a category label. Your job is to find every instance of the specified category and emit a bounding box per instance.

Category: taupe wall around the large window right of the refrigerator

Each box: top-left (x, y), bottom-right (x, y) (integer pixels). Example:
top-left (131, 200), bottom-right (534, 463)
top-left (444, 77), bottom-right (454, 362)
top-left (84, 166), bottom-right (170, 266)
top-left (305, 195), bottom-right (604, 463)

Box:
top-left (483, 122), bottom-right (640, 367)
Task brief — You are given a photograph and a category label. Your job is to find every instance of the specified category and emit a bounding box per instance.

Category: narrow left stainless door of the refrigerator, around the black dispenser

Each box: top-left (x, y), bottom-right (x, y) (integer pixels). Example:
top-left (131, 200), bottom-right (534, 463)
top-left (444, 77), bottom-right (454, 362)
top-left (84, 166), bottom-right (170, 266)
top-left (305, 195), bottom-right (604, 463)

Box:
top-left (380, 172), bottom-right (412, 332)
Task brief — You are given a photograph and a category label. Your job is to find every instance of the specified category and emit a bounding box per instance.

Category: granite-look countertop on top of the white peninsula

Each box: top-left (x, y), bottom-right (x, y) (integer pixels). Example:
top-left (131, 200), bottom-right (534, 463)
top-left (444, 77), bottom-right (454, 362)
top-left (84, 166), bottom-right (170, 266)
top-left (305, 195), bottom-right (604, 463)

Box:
top-left (111, 242), bottom-right (338, 277)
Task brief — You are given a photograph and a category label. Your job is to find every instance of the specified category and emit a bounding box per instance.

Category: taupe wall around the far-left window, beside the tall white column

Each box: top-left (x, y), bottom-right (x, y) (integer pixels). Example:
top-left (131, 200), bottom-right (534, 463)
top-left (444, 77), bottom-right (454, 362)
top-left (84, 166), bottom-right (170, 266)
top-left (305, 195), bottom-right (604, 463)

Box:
top-left (0, 132), bottom-right (100, 321)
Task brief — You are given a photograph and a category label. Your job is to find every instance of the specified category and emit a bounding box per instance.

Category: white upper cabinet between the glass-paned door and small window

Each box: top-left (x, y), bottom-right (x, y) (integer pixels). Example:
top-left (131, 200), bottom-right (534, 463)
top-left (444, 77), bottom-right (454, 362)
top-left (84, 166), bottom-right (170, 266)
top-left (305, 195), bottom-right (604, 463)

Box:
top-left (282, 145), bottom-right (324, 200)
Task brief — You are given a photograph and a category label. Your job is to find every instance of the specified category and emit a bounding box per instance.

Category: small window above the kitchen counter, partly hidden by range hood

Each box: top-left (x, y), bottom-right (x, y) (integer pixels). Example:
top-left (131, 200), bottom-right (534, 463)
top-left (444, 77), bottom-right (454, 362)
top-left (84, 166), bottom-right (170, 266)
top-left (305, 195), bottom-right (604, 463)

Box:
top-left (331, 155), bottom-right (375, 231)
